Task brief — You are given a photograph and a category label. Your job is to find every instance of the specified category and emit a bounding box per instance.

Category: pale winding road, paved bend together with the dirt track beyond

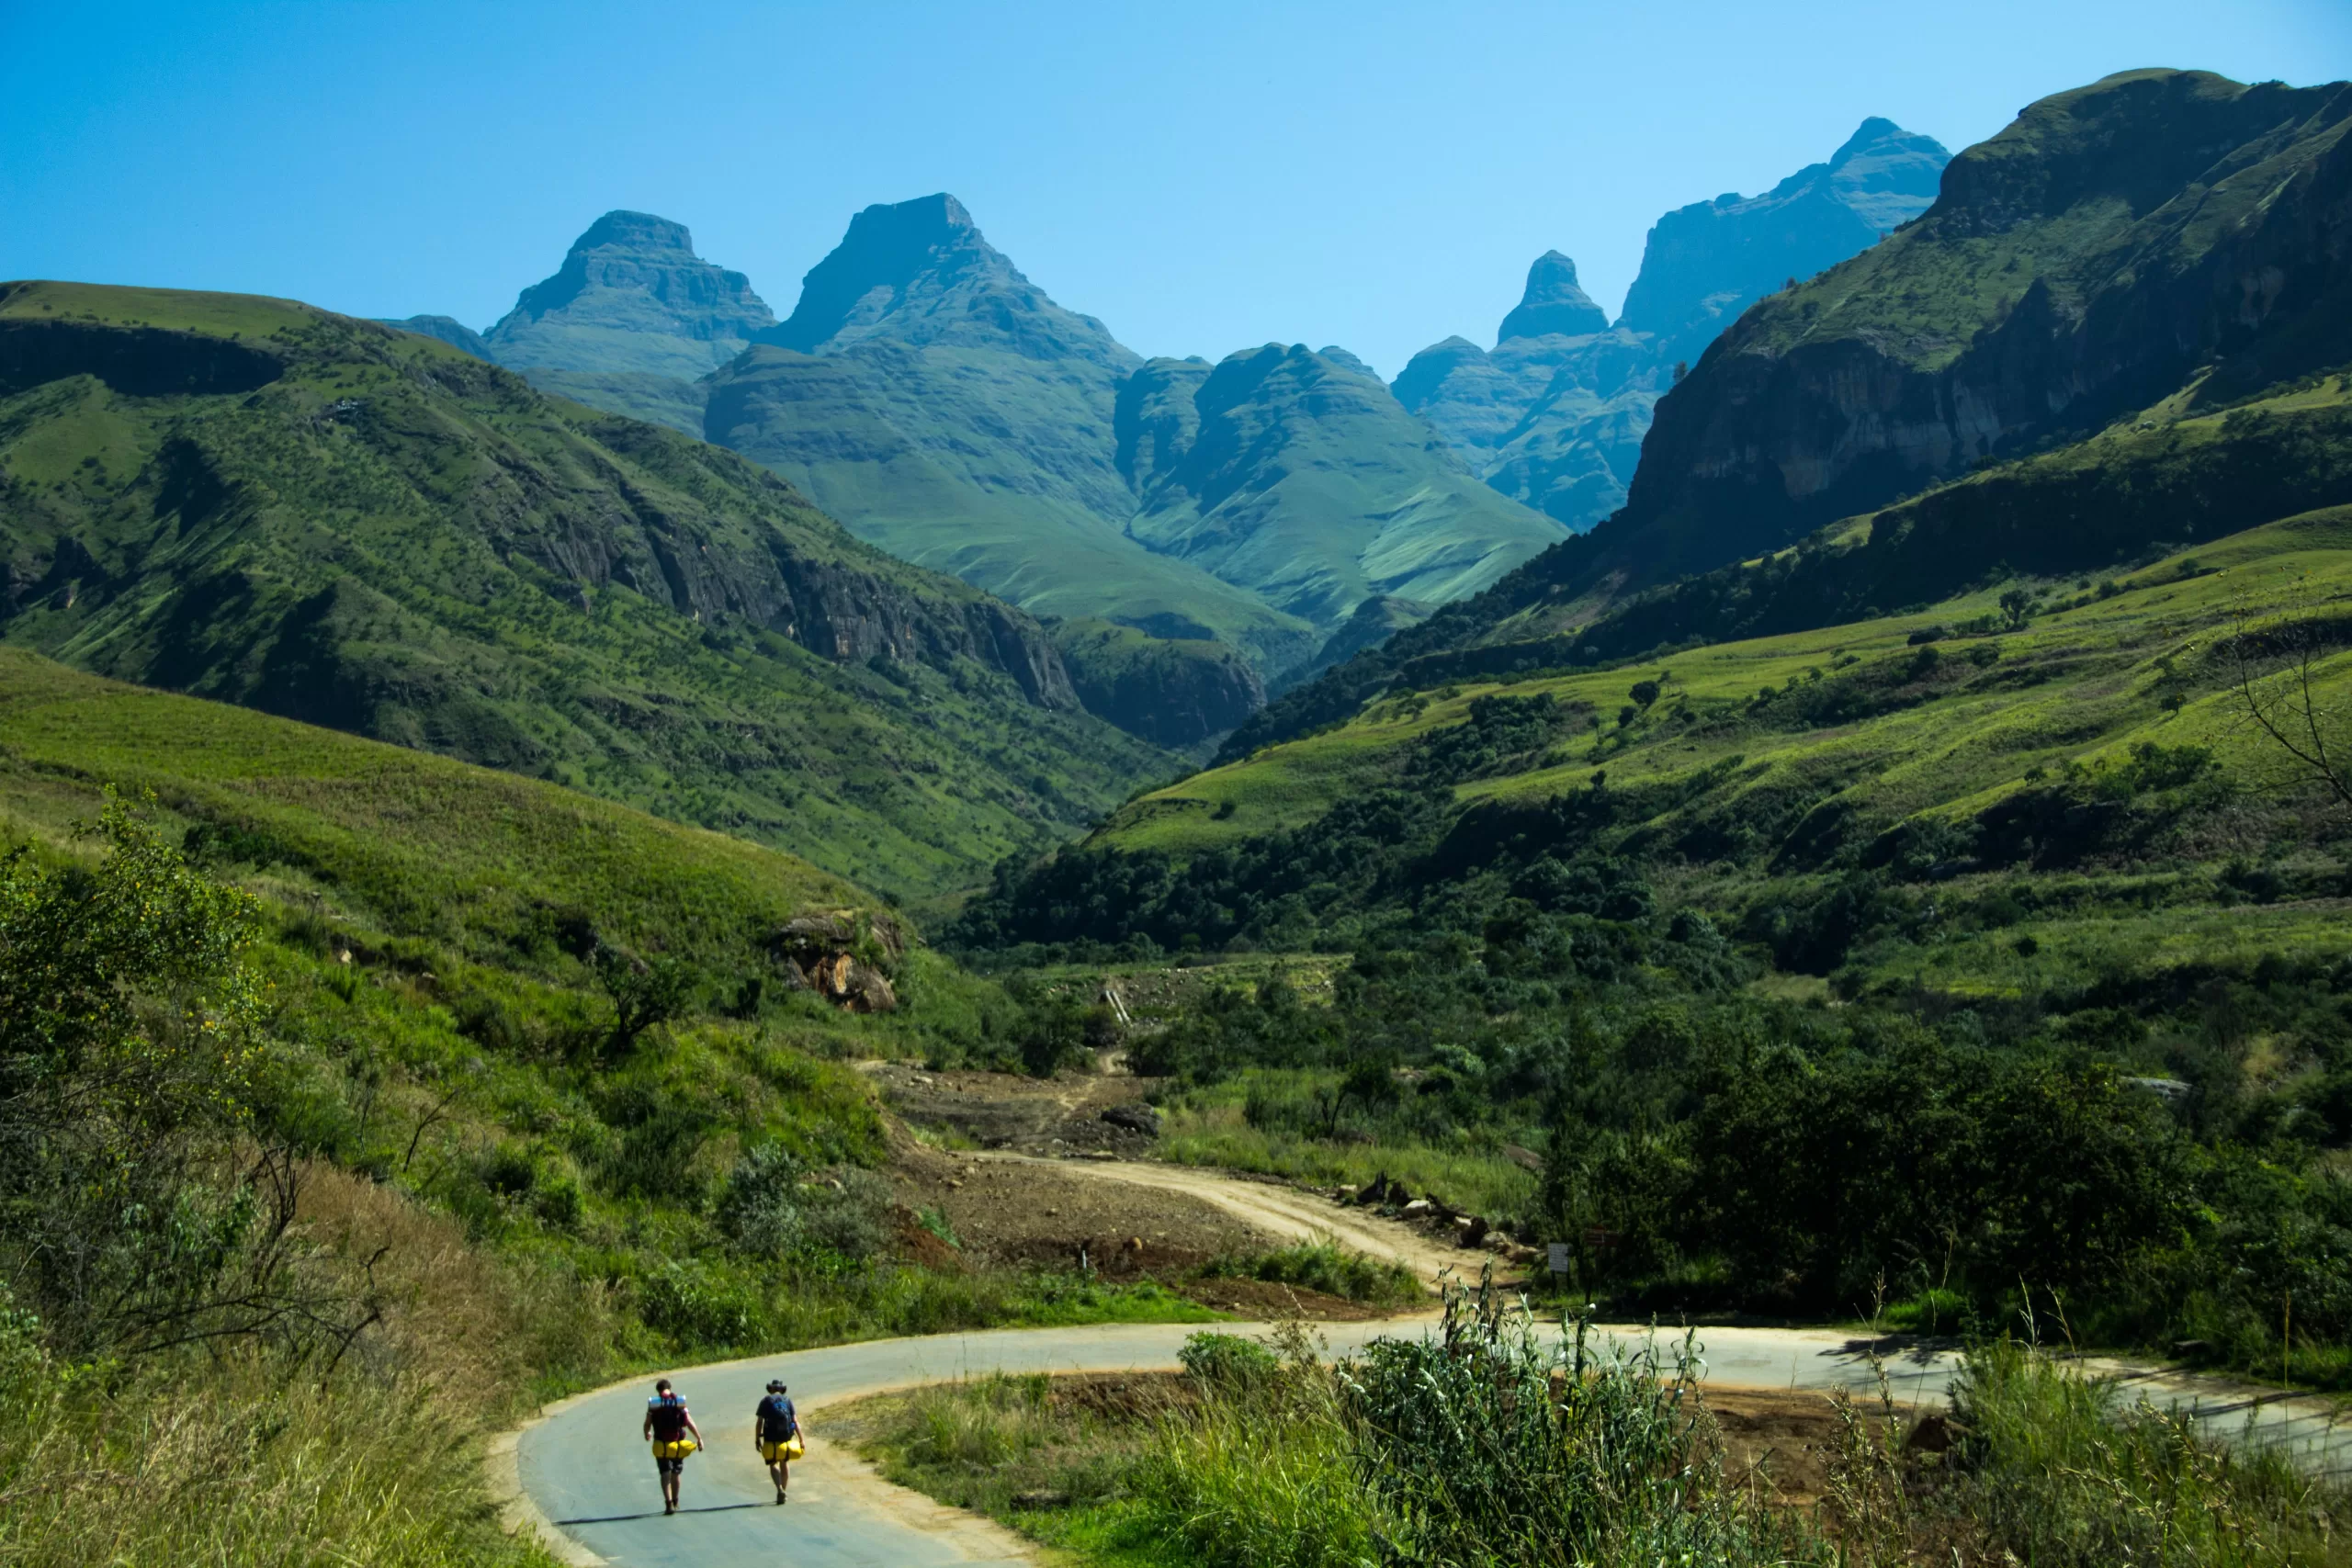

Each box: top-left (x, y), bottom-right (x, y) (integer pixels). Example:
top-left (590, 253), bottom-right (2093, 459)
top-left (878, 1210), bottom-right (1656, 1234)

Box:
top-left (489, 1155), bottom-right (2352, 1568)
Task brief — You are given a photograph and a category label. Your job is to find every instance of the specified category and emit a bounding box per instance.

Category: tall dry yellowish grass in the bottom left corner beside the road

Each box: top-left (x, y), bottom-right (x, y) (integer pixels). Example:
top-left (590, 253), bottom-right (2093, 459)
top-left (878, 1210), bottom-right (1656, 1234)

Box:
top-left (0, 1166), bottom-right (609, 1568)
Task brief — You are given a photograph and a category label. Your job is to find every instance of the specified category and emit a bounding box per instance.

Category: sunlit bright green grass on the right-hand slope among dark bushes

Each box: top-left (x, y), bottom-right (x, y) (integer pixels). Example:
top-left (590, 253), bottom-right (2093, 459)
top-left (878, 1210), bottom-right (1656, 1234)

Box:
top-left (1089, 522), bottom-right (2352, 1001)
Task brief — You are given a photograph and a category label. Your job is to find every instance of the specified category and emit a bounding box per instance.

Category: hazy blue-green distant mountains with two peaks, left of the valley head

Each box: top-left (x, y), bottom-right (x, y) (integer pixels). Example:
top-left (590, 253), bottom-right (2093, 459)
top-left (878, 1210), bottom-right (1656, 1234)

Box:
top-left (451, 195), bottom-right (1553, 700)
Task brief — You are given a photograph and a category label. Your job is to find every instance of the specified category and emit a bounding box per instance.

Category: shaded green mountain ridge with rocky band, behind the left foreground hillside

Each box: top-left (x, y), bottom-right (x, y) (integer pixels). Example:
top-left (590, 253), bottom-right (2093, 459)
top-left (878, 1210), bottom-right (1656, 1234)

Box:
top-left (0, 285), bottom-right (1167, 894)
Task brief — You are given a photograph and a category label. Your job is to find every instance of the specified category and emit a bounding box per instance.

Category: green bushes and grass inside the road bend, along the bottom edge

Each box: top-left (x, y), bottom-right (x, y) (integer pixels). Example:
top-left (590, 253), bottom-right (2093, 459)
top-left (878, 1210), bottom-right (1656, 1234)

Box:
top-left (855, 1293), bottom-right (2352, 1568)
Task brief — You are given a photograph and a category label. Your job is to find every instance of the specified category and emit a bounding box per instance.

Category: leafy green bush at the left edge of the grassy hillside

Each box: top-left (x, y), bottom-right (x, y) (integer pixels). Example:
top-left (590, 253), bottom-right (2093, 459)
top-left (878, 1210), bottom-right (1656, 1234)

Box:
top-left (0, 790), bottom-right (294, 1354)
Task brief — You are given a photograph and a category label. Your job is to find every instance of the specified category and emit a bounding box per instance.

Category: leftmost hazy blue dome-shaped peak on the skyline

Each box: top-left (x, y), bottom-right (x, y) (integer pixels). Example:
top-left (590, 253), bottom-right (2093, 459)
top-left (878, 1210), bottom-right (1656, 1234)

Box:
top-left (481, 211), bottom-right (776, 381)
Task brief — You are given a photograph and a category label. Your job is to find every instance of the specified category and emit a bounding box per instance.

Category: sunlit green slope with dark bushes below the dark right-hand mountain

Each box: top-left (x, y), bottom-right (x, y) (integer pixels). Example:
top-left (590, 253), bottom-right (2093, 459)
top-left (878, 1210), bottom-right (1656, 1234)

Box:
top-left (962, 508), bottom-right (2352, 992)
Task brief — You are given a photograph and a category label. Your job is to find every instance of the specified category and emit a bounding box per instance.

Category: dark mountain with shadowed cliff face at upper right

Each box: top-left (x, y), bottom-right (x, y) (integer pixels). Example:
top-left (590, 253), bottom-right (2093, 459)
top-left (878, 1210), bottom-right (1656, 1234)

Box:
top-left (1609, 71), bottom-right (2352, 581)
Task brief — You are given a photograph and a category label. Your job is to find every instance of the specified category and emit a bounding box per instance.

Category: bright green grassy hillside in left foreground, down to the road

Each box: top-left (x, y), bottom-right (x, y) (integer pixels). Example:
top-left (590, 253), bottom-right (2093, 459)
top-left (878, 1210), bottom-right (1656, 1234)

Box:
top-left (0, 649), bottom-right (1194, 1568)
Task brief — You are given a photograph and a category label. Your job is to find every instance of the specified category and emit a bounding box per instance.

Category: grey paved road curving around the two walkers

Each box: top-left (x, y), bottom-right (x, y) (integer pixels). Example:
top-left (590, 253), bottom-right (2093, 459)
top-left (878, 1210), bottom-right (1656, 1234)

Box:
top-left (515, 1319), bottom-right (1952, 1568)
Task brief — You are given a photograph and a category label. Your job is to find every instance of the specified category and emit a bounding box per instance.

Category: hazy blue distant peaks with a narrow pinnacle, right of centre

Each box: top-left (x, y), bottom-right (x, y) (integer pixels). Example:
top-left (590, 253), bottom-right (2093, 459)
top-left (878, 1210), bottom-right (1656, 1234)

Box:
top-left (1395, 120), bottom-right (1945, 531)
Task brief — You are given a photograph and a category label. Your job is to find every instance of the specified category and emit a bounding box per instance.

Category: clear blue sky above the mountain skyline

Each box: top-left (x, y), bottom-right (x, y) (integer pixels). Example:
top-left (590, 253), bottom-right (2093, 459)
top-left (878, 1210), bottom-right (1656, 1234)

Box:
top-left (0, 0), bottom-right (2352, 374)
